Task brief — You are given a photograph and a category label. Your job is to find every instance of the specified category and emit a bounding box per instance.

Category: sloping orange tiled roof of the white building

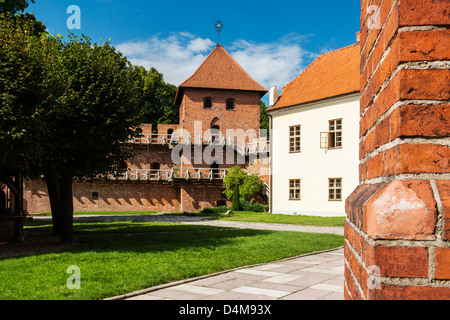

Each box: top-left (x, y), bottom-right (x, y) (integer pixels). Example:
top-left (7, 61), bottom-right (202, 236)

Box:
top-left (268, 43), bottom-right (360, 111)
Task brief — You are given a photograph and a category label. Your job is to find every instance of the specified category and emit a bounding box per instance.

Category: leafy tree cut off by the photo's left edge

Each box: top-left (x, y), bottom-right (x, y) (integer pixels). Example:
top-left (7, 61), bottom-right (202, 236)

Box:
top-left (0, 13), bottom-right (52, 218)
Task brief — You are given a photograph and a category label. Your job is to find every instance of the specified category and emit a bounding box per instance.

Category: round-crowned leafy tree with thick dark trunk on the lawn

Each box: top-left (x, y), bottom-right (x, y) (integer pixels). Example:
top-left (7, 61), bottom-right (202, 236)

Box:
top-left (39, 36), bottom-right (142, 242)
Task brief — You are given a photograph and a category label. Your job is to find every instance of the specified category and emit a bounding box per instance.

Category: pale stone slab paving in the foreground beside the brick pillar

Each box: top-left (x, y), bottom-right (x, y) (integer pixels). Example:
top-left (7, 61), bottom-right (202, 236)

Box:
top-left (118, 248), bottom-right (344, 300)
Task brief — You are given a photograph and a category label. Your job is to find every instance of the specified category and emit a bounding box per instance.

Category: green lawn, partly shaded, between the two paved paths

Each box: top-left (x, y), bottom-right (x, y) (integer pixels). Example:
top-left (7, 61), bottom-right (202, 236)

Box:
top-left (0, 222), bottom-right (344, 300)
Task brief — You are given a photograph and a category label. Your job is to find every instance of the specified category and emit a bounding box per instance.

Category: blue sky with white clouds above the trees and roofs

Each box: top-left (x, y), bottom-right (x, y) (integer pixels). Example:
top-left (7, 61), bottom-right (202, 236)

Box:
top-left (27, 0), bottom-right (360, 102)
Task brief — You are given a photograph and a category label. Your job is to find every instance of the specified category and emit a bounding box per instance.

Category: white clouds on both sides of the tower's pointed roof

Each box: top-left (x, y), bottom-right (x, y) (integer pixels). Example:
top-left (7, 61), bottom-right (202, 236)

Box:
top-left (117, 32), bottom-right (311, 91)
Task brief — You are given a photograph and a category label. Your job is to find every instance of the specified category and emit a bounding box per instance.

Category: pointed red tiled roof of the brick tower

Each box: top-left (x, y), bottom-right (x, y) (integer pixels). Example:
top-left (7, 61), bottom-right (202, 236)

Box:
top-left (175, 44), bottom-right (267, 103)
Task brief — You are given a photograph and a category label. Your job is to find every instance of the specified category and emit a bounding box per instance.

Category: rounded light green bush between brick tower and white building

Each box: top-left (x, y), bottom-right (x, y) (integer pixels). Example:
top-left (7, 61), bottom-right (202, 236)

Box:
top-left (223, 167), bottom-right (263, 201)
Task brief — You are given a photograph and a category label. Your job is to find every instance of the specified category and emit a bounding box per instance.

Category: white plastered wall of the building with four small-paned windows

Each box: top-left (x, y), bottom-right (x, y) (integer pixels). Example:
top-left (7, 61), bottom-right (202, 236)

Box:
top-left (271, 94), bottom-right (360, 216)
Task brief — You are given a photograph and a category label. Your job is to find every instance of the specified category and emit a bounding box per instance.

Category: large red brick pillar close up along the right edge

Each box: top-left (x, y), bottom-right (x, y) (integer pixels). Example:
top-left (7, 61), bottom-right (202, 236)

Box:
top-left (345, 0), bottom-right (450, 300)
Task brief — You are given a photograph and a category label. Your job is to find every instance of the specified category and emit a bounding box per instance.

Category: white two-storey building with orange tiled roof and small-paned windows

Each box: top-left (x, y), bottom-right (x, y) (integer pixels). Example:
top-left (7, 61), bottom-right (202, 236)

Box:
top-left (268, 44), bottom-right (360, 216)
